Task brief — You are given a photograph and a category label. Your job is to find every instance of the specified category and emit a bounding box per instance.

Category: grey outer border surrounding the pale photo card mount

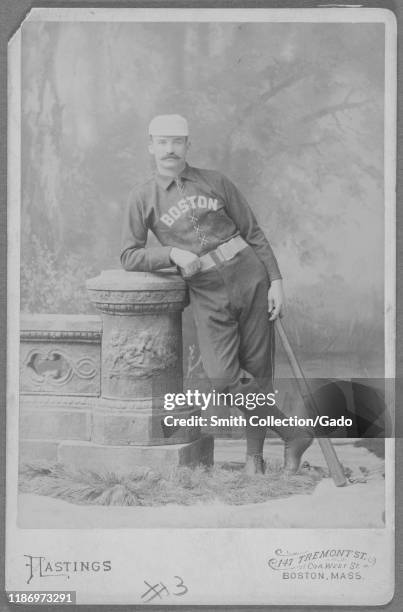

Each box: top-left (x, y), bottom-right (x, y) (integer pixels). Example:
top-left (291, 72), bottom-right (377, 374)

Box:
top-left (0, 0), bottom-right (403, 611)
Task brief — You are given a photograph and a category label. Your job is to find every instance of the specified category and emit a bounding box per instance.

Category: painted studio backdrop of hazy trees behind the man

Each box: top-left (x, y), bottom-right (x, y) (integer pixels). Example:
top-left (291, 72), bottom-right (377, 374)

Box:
top-left (21, 22), bottom-right (384, 377)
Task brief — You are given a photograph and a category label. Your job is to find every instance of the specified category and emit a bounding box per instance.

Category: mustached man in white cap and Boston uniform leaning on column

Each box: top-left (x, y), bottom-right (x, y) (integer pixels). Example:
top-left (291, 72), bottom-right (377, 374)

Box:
top-left (121, 115), bottom-right (311, 475)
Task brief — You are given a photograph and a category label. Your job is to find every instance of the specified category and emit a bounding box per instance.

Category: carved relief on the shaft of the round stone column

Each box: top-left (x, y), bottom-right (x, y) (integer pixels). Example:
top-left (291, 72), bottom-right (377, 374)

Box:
top-left (103, 331), bottom-right (178, 378)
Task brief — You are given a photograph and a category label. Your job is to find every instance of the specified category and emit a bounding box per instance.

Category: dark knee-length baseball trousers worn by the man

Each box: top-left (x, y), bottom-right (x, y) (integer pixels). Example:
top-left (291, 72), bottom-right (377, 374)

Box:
top-left (188, 246), bottom-right (278, 430)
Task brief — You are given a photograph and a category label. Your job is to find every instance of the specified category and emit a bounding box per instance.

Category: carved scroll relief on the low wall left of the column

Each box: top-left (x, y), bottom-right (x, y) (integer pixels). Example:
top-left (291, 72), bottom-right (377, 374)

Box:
top-left (23, 347), bottom-right (98, 387)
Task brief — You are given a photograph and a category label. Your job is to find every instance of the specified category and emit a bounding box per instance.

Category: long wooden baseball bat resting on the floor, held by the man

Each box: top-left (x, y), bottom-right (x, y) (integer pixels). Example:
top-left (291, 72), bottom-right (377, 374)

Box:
top-left (274, 318), bottom-right (347, 487)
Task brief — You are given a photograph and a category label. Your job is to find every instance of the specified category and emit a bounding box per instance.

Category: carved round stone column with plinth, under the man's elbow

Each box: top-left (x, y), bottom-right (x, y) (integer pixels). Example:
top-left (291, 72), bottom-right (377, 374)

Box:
top-left (60, 270), bottom-right (213, 472)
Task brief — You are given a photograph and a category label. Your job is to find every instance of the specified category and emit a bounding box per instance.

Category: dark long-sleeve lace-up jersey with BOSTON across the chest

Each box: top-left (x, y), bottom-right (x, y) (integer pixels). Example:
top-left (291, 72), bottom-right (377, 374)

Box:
top-left (120, 160), bottom-right (281, 281)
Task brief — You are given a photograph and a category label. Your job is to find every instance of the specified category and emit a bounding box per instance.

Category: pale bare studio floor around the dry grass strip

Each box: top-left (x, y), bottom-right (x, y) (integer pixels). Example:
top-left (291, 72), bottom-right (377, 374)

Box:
top-left (18, 439), bottom-right (386, 529)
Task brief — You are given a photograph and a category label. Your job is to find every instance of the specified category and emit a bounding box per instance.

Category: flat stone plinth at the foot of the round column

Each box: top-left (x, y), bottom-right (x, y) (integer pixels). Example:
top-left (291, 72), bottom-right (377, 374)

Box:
top-left (58, 435), bottom-right (214, 475)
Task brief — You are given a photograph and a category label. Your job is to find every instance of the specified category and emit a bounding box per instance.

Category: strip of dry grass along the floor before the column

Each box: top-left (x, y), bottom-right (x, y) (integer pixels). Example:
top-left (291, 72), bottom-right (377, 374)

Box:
top-left (19, 462), bottom-right (324, 506)
